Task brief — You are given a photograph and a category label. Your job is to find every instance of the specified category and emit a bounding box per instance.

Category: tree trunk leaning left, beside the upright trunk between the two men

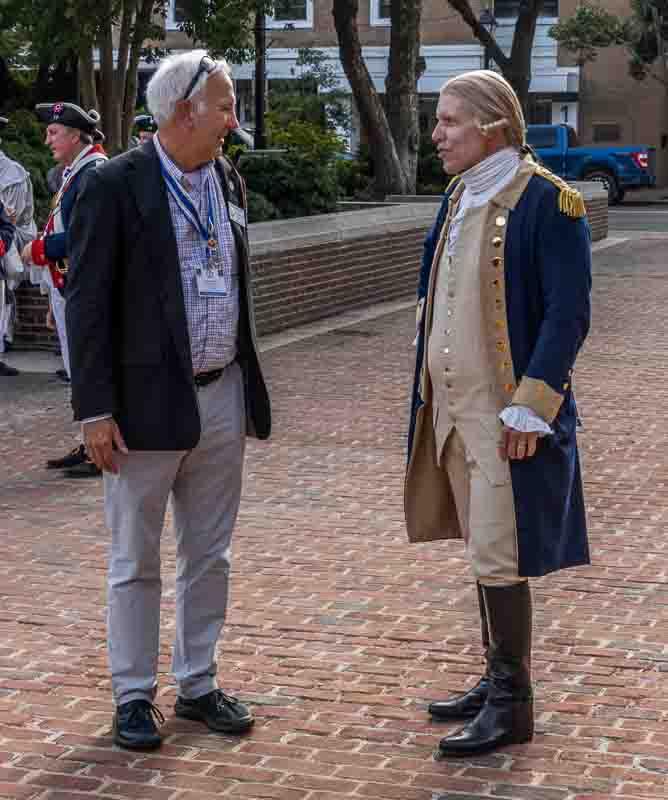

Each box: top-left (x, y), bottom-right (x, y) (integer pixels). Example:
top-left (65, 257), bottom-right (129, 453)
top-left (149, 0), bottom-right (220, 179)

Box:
top-left (333, 0), bottom-right (408, 196)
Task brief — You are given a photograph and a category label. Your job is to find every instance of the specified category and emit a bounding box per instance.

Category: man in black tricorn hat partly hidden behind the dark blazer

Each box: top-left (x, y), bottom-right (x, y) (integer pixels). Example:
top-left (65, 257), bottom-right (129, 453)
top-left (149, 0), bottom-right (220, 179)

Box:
top-left (22, 103), bottom-right (107, 477)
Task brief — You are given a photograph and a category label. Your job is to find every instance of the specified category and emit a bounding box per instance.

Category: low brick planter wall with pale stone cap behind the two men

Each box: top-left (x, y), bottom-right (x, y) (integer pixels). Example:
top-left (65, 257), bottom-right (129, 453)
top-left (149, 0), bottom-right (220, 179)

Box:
top-left (16, 184), bottom-right (608, 350)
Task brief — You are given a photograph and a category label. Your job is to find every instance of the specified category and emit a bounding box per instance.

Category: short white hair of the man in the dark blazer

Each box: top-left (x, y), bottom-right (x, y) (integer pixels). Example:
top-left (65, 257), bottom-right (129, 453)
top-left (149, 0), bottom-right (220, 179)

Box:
top-left (146, 50), bottom-right (232, 127)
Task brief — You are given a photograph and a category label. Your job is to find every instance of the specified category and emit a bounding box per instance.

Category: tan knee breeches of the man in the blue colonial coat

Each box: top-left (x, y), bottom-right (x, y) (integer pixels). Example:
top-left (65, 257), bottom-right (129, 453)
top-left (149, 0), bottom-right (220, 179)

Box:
top-left (441, 429), bottom-right (525, 586)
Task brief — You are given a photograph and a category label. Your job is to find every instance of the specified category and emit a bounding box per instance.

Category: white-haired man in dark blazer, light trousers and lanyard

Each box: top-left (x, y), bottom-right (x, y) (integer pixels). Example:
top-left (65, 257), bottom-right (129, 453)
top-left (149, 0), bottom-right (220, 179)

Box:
top-left (67, 51), bottom-right (270, 749)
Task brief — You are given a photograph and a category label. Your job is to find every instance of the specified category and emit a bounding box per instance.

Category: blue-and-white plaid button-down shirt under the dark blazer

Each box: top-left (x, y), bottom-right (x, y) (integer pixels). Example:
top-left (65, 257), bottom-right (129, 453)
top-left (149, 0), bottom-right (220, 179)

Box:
top-left (153, 135), bottom-right (239, 374)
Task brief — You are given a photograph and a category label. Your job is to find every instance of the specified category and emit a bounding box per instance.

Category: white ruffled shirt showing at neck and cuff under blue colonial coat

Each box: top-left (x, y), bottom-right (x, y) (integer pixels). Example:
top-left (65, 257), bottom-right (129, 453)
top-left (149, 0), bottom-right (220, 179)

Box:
top-left (447, 147), bottom-right (553, 436)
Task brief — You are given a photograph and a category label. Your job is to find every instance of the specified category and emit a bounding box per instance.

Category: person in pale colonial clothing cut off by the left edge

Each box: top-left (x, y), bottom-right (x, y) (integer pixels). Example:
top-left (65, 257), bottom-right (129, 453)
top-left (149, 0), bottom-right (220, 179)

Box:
top-left (0, 117), bottom-right (37, 375)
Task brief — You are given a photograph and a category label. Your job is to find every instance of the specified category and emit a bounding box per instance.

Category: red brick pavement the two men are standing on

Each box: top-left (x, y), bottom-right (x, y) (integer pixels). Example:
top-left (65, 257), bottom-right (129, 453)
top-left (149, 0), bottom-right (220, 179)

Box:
top-left (0, 236), bottom-right (668, 800)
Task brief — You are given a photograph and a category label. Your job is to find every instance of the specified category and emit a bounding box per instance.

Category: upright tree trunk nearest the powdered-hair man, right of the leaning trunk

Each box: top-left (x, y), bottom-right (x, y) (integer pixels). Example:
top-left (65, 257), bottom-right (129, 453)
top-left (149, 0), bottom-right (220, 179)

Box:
top-left (385, 0), bottom-right (422, 194)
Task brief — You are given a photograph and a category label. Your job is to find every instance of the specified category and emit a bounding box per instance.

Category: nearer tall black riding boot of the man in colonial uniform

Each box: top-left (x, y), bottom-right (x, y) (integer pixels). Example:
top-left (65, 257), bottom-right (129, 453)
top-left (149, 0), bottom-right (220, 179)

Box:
top-left (439, 581), bottom-right (533, 756)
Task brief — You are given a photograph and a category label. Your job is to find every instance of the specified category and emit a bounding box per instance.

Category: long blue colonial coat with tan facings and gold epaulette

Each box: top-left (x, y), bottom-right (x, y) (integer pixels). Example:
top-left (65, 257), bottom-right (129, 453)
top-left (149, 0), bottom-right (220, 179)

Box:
top-left (404, 162), bottom-right (591, 577)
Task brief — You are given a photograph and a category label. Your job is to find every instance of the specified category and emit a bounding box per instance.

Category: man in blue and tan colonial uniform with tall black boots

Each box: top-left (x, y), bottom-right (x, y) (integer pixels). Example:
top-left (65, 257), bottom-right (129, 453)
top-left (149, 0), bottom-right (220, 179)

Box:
top-left (404, 70), bottom-right (591, 756)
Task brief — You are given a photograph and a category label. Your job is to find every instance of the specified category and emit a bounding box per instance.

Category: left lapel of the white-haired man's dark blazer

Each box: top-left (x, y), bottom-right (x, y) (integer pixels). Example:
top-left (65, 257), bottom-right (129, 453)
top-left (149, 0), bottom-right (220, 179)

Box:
top-left (129, 142), bottom-right (193, 376)
